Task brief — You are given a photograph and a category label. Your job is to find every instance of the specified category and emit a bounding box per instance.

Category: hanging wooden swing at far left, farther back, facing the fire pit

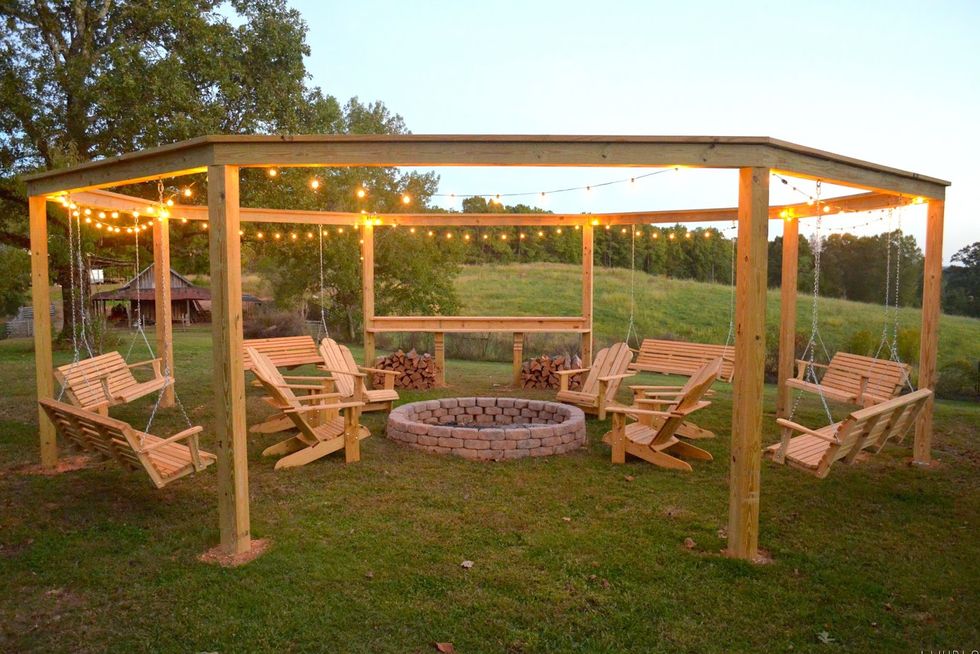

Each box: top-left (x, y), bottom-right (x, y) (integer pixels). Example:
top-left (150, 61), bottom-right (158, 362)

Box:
top-left (54, 352), bottom-right (174, 415)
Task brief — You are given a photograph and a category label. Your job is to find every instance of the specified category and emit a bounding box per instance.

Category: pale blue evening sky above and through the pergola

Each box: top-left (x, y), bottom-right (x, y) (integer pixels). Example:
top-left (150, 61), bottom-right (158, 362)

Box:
top-left (290, 0), bottom-right (980, 263)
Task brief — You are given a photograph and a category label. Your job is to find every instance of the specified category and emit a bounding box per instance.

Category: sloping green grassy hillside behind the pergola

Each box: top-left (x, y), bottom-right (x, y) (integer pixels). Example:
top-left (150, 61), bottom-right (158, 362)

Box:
top-left (449, 264), bottom-right (980, 366)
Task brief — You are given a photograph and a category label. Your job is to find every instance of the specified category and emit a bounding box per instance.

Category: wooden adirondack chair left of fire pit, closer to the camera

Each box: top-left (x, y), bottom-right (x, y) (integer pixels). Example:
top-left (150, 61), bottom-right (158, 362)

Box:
top-left (249, 348), bottom-right (371, 470)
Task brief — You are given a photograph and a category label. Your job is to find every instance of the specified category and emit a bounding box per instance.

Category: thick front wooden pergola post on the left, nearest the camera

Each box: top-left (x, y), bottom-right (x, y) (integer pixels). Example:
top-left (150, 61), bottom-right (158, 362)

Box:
top-left (208, 166), bottom-right (251, 554)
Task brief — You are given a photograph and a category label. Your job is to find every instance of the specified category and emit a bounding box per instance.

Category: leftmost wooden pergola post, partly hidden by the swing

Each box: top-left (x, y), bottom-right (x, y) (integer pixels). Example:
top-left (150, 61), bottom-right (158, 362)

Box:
top-left (28, 196), bottom-right (58, 469)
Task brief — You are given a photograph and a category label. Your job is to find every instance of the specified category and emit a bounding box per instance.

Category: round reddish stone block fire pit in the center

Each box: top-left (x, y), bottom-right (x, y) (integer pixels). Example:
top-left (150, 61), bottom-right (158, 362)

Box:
top-left (387, 397), bottom-right (585, 461)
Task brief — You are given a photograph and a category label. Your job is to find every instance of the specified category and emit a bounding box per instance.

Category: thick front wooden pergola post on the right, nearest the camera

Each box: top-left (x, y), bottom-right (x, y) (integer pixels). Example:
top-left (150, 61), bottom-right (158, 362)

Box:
top-left (728, 168), bottom-right (769, 560)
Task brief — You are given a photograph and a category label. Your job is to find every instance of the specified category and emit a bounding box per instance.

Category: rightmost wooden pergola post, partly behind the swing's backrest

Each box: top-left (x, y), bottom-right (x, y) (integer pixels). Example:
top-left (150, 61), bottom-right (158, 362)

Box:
top-left (912, 200), bottom-right (945, 466)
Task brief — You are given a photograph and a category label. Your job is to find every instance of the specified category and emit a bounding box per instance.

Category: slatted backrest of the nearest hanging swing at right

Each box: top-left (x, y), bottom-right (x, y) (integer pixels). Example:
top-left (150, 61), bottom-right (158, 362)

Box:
top-left (817, 388), bottom-right (932, 475)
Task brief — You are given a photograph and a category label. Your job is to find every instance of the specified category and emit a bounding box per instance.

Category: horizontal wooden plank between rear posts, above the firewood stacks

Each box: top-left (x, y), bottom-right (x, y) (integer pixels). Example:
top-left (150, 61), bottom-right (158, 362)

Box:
top-left (367, 316), bottom-right (588, 333)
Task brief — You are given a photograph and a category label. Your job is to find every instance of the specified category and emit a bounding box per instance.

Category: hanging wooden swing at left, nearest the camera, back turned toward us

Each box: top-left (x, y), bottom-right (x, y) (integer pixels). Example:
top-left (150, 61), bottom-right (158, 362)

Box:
top-left (40, 399), bottom-right (216, 488)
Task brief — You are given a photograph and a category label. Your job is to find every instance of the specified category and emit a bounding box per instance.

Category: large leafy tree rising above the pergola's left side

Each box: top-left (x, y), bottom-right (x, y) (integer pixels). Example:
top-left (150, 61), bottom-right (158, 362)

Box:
top-left (0, 0), bottom-right (334, 332)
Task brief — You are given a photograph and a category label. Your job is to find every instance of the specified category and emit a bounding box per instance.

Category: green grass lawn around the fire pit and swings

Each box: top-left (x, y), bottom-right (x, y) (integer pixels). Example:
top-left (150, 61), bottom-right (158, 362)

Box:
top-left (0, 330), bottom-right (980, 652)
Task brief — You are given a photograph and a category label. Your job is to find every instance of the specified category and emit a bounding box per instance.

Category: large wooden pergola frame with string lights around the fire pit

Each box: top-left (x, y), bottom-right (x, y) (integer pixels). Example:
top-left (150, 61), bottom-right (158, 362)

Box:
top-left (27, 135), bottom-right (949, 560)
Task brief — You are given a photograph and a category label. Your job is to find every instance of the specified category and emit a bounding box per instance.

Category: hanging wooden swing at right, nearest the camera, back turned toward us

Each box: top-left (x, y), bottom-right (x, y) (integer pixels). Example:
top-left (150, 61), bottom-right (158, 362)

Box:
top-left (766, 388), bottom-right (932, 479)
